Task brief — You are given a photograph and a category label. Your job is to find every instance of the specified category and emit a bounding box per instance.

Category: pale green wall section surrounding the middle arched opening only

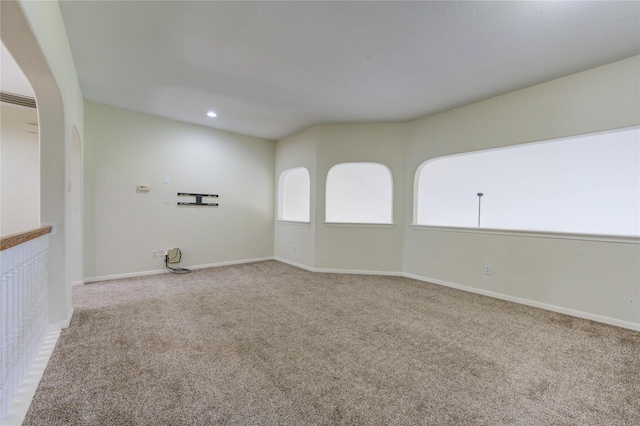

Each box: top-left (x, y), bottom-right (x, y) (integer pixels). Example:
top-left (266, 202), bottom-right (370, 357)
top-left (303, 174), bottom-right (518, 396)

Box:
top-left (312, 123), bottom-right (407, 273)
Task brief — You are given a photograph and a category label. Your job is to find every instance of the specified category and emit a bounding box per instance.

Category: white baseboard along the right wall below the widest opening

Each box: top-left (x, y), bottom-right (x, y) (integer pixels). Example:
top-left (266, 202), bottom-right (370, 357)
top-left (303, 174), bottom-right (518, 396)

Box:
top-left (404, 273), bottom-right (640, 331)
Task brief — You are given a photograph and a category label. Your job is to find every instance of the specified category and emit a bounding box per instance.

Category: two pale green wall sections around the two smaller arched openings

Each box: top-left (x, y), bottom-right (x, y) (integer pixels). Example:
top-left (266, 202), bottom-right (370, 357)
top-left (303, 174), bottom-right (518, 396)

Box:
top-left (275, 123), bottom-right (407, 273)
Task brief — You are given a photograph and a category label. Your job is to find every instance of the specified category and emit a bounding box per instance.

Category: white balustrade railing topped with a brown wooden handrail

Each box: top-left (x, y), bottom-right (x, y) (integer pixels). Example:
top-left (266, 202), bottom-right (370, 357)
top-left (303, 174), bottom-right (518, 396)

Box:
top-left (0, 227), bottom-right (51, 418)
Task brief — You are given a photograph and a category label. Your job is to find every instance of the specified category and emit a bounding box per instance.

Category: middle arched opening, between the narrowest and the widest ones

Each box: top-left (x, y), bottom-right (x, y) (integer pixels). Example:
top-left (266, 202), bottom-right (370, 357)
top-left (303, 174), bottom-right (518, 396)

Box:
top-left (325, 163), bottom-right (393, 224)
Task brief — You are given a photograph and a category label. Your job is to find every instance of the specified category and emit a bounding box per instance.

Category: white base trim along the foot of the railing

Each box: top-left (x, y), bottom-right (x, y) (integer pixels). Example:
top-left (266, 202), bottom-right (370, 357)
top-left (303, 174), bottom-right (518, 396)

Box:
top-left (2, 329), bottom-right (60, 426)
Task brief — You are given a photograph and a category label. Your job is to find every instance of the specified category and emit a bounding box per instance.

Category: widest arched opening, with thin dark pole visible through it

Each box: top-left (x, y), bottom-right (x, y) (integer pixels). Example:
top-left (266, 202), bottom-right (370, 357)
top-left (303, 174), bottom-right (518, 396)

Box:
top-left (414, 128), bottom-right (640, 236)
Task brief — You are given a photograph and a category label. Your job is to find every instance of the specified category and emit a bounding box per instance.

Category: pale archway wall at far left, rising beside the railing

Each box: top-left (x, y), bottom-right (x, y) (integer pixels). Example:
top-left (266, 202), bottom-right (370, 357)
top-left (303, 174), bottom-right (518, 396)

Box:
top-left (0, 1), bottom-right (83, 328)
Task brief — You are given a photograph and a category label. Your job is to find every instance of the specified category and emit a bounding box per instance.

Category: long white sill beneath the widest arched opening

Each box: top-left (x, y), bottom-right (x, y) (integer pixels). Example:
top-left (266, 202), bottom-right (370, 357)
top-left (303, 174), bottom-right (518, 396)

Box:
top-left (409, 224), bottom-right (640, 244)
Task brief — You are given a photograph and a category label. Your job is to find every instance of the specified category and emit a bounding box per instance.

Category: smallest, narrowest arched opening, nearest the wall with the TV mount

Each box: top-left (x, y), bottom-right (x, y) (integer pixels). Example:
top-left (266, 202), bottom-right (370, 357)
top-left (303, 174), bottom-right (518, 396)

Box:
top-left (278, 167), bottom-right (311, 222)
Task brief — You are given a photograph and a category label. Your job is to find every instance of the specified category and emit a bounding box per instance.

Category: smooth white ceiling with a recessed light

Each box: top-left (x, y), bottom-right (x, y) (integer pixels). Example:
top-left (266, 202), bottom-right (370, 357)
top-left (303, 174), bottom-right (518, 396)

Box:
top-left (60, 1), bottom-right (640, 139)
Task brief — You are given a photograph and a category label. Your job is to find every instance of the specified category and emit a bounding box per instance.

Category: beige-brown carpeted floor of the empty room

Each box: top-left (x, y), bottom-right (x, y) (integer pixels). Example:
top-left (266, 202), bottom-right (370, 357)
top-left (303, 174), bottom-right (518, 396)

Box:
top-left (24, 261), bottom-right (640, 425)
